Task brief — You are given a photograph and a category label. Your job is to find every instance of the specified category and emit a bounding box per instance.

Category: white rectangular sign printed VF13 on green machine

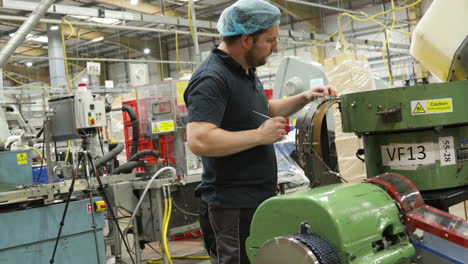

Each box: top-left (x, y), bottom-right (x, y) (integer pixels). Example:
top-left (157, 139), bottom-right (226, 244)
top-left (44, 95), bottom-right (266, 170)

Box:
top-left (381, 142), bottom-right (436, 167)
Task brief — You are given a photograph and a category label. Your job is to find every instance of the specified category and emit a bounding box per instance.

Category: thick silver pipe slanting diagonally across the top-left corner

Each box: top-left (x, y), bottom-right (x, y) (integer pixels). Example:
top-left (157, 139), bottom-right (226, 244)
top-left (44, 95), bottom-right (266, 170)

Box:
top-left (0, 0), bottom-right (55, 68)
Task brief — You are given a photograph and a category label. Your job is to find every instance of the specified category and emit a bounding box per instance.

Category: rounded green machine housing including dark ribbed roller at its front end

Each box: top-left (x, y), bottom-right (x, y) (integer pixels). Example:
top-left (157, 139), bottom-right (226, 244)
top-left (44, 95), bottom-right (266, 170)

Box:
top-left (246, 183), bottom-right (415, 264)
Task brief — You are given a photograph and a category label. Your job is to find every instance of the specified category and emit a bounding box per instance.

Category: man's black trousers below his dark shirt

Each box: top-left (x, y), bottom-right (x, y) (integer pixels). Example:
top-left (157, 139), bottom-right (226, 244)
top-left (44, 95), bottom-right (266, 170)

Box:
top-left (200, 201), bottom-right (255, 264)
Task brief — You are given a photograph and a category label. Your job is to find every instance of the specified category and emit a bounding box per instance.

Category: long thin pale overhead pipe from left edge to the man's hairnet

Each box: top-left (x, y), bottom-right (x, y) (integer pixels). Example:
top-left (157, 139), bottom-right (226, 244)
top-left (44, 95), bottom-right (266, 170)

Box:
top-left (0, 15), bottom-right (219, 37)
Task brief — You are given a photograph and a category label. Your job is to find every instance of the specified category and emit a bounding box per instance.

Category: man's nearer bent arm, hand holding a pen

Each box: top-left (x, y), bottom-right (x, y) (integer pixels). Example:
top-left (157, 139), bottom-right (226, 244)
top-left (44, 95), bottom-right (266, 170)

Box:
top-left (187, 117), bottom-right (286, 157)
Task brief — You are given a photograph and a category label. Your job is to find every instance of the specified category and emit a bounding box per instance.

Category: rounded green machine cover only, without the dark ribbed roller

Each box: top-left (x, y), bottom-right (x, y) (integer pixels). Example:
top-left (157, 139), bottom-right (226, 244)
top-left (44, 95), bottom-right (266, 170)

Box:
top-left (246, 183), bottom-right (414, 264)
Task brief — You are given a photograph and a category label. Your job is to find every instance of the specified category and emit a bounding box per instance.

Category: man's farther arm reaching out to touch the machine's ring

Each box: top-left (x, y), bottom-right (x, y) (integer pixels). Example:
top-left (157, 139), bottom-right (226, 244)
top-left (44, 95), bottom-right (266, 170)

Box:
top-left (268, 86), bottom-right (338, 117)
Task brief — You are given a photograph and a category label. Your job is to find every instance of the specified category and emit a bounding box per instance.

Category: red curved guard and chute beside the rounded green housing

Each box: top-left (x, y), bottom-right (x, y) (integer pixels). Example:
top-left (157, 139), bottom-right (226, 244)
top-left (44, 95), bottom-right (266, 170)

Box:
top-left (366, 173), bottom-right (468, 248)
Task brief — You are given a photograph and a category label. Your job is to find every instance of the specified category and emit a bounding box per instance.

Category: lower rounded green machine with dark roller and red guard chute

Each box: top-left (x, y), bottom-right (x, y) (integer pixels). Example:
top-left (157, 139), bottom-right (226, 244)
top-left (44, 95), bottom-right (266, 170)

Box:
top-left (246, 173), bottom-right (468, 264)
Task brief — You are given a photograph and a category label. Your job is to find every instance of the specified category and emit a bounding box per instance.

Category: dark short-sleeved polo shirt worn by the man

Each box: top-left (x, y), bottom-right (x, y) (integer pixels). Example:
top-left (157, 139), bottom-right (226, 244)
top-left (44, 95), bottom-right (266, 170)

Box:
top-left (184, 47), bottom-right (277, 208)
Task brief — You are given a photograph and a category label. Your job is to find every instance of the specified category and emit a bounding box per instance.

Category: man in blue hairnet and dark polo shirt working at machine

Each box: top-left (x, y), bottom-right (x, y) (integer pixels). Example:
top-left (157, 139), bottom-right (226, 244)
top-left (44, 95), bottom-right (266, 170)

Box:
top-left (184, 0), bottom-right (337, 264)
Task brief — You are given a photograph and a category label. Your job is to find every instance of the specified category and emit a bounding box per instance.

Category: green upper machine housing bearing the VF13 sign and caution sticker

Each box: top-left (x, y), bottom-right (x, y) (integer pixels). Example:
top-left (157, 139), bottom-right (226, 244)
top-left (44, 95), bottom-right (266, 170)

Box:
top-left (341, 81), bottom-right (468, 191)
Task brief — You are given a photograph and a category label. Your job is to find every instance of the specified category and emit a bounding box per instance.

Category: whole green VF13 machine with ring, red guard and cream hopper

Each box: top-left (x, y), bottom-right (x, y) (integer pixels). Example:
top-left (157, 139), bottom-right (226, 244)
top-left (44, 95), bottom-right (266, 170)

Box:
top-left (246, 0), bottom-right (468, 264)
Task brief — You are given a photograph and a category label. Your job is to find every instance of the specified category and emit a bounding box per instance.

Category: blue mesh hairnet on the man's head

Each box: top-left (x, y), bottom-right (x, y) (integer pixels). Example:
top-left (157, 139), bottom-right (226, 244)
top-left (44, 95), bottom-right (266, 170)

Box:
top-left (216, 0), bottom-right (281, 36)
